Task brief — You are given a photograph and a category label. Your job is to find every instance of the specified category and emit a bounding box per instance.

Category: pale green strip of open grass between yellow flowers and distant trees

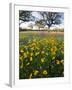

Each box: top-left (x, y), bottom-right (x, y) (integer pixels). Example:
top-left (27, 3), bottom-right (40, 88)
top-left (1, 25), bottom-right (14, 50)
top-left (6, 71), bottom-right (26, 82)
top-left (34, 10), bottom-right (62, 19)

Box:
top-left (19, 31), bottom-right (64, 45)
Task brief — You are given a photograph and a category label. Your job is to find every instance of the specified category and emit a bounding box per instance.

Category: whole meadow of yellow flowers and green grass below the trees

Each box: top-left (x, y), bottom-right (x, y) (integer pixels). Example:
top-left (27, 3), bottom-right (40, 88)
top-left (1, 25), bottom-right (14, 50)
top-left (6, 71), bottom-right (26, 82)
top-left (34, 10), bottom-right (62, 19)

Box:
top-left (19, 32), bottom-right (64, 79)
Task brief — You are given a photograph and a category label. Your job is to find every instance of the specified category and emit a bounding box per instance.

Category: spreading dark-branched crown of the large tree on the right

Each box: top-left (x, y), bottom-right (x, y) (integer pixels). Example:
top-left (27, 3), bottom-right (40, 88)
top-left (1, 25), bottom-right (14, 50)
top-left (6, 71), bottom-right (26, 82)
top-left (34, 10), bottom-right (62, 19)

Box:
top-left (39, 12), bottom-right (62, 28)
